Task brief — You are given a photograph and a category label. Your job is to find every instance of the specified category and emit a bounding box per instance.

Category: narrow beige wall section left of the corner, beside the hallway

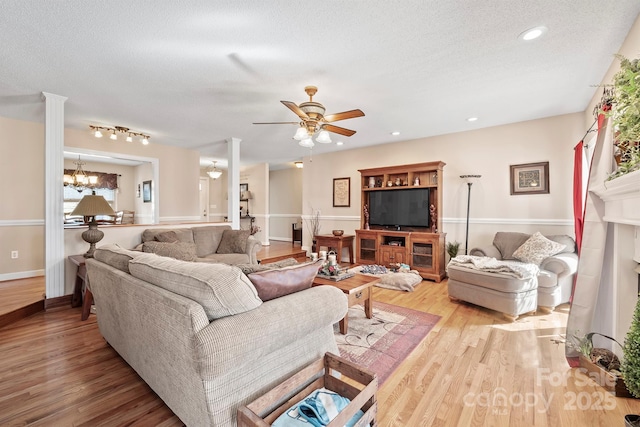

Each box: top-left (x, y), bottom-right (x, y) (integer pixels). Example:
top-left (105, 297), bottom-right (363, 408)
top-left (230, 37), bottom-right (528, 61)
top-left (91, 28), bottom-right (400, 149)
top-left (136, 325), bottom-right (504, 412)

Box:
top-left (269, 168), bottom-right (303, 242)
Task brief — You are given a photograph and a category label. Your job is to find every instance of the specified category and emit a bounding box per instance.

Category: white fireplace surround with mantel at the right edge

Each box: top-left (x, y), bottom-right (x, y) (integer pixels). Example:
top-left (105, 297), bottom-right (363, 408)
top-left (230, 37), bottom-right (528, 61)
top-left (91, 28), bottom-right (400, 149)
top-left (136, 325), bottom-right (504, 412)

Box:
top-left (589, 171), bottom-right (640, 353)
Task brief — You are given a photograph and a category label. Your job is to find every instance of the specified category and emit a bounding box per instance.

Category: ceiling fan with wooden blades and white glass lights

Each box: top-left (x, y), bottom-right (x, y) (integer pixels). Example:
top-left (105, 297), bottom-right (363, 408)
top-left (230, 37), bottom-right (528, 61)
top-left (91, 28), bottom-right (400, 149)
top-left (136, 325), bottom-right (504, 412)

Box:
top-left (254, 86), bottom-right (364, 147)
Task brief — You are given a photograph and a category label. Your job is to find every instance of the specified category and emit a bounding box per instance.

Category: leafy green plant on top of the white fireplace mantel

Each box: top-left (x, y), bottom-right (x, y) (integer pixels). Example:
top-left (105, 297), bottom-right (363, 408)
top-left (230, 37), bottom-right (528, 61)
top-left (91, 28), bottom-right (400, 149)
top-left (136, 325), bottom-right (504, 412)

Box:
top-left (606, 55), bottom-right (640, 180)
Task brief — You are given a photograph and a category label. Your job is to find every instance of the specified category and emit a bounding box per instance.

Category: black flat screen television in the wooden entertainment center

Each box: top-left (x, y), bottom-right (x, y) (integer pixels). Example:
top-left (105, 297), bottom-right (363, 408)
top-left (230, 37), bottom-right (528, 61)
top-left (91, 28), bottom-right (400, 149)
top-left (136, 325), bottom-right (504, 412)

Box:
top-left (369, 188), bottom-right (430, 227)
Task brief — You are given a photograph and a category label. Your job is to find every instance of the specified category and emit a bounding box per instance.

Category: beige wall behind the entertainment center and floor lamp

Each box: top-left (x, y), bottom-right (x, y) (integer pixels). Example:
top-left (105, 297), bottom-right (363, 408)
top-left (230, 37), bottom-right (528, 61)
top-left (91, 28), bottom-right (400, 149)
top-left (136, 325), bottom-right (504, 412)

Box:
top-left (303, 113), bottom-right (586, 256)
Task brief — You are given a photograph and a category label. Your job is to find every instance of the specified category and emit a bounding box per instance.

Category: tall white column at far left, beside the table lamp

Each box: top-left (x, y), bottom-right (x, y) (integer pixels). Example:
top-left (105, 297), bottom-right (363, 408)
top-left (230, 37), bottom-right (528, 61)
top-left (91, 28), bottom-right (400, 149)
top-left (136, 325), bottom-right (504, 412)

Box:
top-left (42, 92), bottom-right (67, 298)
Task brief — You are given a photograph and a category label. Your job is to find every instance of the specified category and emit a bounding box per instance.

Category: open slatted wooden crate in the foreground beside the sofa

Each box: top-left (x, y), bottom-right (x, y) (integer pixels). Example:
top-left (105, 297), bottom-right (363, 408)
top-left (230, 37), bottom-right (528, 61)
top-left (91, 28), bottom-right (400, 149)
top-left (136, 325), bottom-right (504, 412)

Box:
top-left (238, 353), bottom-right (378, 427)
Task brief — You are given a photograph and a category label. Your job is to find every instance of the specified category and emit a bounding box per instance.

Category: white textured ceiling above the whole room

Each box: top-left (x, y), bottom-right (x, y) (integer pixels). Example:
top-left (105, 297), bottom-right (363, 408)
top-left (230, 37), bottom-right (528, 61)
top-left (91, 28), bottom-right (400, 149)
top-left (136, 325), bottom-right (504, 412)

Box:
top-left (0, 0), bottom-right (640, 167)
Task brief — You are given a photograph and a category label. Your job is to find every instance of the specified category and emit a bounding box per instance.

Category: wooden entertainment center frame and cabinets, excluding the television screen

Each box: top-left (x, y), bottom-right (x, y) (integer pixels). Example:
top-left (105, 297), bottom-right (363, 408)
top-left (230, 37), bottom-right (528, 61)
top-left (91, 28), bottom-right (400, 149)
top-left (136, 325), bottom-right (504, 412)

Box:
top-left (356, 162), bottom-right (445, 282)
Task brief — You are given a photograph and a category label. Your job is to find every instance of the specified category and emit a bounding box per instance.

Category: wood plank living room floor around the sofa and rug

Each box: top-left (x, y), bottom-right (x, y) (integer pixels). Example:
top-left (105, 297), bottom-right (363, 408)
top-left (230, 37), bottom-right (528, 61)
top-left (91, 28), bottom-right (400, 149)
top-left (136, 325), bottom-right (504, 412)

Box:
top-left (0, 247), bottom-right (640, 426)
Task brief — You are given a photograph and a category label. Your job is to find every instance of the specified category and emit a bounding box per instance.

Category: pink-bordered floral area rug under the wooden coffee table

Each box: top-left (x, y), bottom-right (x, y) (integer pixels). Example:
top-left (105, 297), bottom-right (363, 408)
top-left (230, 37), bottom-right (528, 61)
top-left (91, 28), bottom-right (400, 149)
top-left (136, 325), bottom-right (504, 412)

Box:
top-left (334, 301), bottom-right (440, 384)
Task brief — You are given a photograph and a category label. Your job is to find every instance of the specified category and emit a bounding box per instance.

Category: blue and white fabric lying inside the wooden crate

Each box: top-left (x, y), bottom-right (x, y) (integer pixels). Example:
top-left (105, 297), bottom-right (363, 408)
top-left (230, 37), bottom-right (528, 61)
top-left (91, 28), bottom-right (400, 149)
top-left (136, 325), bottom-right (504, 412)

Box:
top-left (271, 388), bottom-right (364, 427)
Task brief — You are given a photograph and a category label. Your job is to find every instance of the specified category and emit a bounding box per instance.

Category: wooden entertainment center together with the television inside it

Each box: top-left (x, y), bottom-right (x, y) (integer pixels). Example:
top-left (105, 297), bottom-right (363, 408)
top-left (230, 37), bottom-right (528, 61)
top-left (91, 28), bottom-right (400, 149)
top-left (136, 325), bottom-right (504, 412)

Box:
top-left (356, 162), bottom-right (445, 282)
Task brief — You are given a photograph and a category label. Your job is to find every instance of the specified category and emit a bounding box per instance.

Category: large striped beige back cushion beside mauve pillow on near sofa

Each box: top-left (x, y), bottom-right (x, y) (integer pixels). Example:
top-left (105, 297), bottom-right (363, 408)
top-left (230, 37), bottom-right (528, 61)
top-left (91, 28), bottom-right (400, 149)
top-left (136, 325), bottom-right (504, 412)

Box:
top-left (129, 254), bottom-right (262, 321)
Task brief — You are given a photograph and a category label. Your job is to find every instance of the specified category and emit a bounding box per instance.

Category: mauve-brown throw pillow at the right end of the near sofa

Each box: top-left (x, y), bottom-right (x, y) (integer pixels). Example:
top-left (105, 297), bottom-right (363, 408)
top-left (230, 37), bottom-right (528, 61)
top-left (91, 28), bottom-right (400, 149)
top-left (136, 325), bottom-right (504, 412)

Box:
top-left (248, 260), bottom-right (322, 301)
